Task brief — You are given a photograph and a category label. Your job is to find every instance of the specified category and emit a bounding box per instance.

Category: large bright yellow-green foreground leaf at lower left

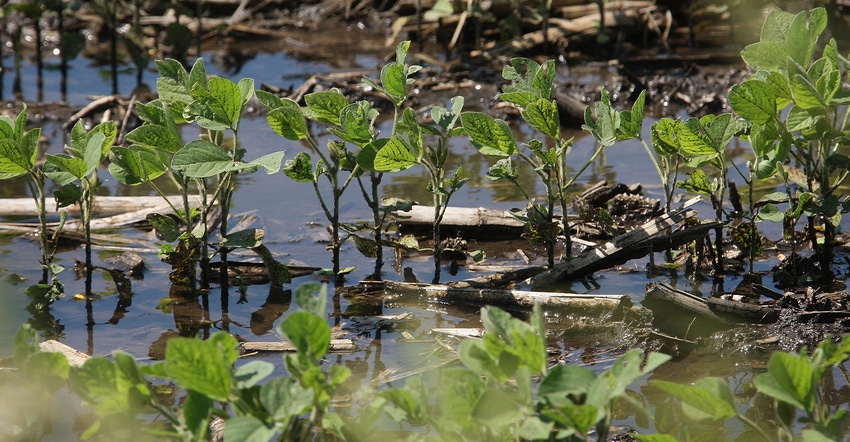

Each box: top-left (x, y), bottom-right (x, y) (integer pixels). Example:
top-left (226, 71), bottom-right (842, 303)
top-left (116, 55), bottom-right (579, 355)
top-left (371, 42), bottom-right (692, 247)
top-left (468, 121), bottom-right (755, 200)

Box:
top-left (165, 333), bottom-right (238, 402)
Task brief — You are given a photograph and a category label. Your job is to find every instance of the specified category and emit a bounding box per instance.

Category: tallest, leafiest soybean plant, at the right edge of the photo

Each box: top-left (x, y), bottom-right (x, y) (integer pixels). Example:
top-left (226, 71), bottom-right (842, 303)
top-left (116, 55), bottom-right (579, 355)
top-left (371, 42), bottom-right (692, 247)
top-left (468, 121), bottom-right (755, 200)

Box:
top-left (729, 8), bottom-right (850, 274)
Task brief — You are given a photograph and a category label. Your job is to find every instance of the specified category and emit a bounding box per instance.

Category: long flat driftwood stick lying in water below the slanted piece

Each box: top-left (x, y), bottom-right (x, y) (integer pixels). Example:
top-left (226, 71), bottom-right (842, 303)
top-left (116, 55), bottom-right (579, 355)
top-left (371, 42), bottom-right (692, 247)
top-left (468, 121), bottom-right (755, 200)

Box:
top-left (384, 281), bottom-right (632, 309)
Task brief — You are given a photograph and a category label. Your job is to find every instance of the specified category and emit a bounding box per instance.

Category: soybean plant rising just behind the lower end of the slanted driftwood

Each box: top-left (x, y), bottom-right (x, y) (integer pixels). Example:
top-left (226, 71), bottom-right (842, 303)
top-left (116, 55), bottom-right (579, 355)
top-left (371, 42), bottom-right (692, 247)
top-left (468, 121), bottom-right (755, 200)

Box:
top-left (461, 58), bottom-right (643, 267)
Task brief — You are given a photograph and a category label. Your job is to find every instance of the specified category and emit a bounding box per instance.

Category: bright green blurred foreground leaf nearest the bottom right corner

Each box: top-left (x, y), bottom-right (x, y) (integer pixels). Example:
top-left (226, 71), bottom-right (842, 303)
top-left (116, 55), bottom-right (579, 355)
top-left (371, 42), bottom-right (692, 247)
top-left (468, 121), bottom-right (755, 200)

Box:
top-left (753, 352), bottom-right (817, 412)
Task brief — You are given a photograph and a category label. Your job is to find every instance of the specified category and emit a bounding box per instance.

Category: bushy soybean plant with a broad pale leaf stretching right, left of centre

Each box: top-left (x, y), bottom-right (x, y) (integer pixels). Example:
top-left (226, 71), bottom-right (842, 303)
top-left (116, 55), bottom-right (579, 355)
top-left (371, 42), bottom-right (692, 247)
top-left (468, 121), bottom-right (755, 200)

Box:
top-left (110, 59), bottom-right (288, 294)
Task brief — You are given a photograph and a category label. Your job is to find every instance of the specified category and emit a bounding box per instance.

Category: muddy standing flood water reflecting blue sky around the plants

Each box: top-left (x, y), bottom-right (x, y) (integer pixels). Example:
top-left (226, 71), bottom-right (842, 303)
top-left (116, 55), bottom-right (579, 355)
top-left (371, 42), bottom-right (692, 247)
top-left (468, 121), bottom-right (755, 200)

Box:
top-left (0, 12), bottom-right (850, 440)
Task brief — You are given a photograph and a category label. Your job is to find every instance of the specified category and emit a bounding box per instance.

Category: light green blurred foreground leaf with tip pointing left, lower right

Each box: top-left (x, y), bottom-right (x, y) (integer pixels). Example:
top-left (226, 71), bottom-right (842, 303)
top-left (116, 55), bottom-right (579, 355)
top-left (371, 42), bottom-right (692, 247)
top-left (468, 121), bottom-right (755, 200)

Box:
top-left (651, 378), bottom-right (738, 421)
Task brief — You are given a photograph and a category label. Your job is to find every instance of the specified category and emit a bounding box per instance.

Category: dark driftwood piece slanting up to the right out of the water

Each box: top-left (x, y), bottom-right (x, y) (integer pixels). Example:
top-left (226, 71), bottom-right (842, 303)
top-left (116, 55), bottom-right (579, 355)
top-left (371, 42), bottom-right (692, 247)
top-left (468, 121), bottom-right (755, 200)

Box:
top-left (526, 198), bottom-right (699, 288)
